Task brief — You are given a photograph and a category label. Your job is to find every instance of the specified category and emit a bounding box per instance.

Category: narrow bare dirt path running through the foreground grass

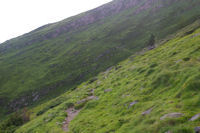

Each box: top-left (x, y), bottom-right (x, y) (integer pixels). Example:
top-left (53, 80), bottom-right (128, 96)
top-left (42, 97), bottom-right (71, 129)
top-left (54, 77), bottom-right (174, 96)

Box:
top-left (63, 89), bottom-right (96, 132)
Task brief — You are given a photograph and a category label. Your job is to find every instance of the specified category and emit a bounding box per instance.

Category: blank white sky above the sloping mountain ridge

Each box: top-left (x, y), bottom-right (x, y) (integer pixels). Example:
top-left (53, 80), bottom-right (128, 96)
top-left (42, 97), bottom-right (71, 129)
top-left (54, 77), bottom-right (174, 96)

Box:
top-left (0, 0), bottom-right (112, 43)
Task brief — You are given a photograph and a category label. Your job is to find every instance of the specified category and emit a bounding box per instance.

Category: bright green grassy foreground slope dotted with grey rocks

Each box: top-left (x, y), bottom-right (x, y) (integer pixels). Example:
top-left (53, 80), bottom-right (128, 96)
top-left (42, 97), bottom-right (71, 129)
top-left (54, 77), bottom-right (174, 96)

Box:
top-left (8, 21), bottom-right (200, 133)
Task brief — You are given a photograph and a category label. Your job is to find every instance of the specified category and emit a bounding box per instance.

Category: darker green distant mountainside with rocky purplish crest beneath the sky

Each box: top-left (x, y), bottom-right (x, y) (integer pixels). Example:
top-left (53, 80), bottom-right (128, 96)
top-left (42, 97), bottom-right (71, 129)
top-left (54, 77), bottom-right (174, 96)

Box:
top-left (0, 0), bottom-right (200, 113)
